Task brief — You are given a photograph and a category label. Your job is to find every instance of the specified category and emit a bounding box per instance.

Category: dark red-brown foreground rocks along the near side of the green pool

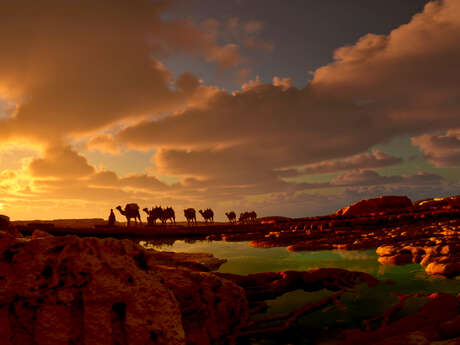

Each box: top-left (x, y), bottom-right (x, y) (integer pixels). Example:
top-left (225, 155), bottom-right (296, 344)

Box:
top-left (0, 226), bottom-right (460, 345)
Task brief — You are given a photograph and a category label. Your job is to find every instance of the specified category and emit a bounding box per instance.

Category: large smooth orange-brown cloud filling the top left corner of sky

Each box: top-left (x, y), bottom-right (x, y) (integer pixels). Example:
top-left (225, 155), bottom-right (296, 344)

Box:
top-left (0, 0), bottom-right (245, 142)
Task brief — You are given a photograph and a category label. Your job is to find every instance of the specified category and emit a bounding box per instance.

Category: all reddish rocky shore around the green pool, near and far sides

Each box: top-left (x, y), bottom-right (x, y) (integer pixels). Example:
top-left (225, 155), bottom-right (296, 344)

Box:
top-left (0, 197), bottom-right (460, 345)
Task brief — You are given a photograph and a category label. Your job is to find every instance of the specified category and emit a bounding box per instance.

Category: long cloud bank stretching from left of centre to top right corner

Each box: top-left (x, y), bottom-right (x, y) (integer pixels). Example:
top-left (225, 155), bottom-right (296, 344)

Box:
top-left (106, 0), bottom-right (460, 202)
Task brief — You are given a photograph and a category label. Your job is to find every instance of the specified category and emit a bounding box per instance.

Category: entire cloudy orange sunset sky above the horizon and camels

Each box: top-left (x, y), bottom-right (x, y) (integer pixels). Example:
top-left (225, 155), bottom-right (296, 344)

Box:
top-left (0, 0), bottom-right (460, 220)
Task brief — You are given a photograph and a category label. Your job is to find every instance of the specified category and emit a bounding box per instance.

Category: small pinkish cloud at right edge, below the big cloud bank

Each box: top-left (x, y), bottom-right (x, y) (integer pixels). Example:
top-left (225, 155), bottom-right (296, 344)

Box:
top-left (412, 129), bottom-right (460, 168)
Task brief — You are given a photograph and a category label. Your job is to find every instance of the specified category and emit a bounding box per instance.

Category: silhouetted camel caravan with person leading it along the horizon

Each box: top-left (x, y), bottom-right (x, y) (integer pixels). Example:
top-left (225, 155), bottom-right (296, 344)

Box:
top-left (108, 203), bottom-right (257, 226)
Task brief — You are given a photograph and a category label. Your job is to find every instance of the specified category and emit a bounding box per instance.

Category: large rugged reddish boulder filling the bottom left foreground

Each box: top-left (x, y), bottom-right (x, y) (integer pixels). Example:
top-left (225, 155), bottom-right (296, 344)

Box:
top-left (0, 233), bottom-right (248, 345)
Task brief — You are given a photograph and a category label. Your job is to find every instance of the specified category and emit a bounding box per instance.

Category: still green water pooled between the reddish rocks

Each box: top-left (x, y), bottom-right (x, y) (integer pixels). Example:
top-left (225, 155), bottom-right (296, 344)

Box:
top-left (141, 241), bottom-right (460, 345)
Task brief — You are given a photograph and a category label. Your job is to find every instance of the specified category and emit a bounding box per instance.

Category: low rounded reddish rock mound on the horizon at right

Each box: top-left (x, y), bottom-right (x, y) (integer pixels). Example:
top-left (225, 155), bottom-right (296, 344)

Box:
top-left (336, 196), bottom-right (412, 217)
